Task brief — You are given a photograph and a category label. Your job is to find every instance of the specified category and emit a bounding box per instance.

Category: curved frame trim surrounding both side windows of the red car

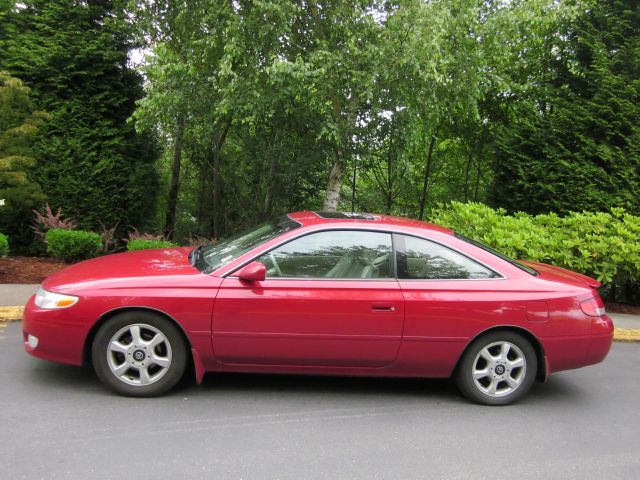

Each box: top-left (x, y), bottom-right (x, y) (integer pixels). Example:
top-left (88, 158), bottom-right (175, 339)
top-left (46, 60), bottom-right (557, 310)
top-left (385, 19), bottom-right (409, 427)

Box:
top-left (220, 226), bottom-right (508, 282)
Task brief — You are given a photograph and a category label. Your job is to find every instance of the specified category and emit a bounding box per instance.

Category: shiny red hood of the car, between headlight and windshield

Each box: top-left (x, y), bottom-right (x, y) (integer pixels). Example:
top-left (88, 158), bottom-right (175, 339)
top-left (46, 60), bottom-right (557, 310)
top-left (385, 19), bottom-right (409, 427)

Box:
top-left (42, 247), bottom-right (202, 292)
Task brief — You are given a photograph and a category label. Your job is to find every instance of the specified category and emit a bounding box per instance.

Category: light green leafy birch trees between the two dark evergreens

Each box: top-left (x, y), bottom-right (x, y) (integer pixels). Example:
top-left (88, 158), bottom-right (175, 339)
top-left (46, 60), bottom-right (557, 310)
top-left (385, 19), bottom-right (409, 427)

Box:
top-left (135, 0), bottom-right (576, 238)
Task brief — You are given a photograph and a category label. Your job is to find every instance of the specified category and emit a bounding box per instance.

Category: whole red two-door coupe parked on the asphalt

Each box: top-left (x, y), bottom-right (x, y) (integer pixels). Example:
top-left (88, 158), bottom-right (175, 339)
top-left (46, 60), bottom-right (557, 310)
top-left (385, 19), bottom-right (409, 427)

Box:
top-left (23, 212), bottom-right (613, 405)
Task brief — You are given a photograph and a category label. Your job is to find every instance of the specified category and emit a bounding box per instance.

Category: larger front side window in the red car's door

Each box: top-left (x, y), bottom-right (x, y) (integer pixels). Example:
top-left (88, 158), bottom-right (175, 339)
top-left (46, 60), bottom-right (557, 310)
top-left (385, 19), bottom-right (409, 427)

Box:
top-left (258, 230), bottom-right (393, 278)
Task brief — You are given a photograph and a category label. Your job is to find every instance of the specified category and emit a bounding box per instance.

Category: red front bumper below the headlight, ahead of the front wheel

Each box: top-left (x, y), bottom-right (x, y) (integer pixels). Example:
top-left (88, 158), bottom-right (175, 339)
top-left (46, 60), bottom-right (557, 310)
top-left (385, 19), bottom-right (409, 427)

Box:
top-left (22, 297), bottom-right (88, 365)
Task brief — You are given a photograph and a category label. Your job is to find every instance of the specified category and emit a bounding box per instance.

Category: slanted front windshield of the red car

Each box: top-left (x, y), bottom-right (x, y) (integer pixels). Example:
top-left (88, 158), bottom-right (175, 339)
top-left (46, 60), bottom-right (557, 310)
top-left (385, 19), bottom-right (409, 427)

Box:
top-left (195, 215), bottom-right (300, 273)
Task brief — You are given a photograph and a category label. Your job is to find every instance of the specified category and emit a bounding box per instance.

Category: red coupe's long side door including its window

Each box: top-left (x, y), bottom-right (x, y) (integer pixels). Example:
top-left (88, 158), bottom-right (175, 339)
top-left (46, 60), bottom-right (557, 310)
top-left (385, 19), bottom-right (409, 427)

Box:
top-left (212, 230), bottom-right (404, 367)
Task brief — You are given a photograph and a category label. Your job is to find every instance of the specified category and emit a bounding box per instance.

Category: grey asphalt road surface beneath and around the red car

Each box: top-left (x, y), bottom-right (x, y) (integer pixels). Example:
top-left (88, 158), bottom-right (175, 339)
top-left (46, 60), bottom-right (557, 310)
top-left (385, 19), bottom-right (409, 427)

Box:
top-left (0, 323), bottom-right (640, 480)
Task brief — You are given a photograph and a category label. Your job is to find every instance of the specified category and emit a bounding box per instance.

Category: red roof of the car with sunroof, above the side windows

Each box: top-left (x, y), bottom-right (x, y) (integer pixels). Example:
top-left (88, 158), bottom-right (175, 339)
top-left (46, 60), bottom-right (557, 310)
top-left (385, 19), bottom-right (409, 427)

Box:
top-left (289, 210), bottom-right (453, 235)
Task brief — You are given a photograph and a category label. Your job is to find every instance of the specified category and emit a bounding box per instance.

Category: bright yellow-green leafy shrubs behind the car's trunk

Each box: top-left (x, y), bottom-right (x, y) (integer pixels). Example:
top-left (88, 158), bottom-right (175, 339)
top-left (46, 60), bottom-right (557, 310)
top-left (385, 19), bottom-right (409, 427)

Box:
top-left (431, 202), bottom-right (640, 301)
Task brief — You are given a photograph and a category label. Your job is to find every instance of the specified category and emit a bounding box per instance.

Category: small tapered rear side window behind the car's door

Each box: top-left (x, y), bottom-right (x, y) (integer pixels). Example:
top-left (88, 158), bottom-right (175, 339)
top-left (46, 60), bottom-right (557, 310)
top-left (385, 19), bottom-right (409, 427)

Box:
top-left (396, 235), bottom-right (500, 280)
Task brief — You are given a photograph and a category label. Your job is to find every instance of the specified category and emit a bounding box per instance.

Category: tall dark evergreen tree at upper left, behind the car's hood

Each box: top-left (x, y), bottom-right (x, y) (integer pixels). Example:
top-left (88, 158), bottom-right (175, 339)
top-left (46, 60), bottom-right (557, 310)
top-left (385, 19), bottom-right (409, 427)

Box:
top-left (0, 0), bottom-right (157, 240)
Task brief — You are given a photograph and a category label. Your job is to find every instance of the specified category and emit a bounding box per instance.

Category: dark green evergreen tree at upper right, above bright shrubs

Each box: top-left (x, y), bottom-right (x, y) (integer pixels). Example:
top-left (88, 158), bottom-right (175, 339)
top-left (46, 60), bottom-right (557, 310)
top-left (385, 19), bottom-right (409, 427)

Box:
top-left (492, 0), bottom-right (640, 215)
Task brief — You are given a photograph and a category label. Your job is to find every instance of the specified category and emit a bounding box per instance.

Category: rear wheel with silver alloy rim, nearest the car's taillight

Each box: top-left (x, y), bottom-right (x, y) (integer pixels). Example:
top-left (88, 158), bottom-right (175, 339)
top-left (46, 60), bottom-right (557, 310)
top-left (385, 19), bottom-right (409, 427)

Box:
top-left (455, 331), bottom-right (538, 406)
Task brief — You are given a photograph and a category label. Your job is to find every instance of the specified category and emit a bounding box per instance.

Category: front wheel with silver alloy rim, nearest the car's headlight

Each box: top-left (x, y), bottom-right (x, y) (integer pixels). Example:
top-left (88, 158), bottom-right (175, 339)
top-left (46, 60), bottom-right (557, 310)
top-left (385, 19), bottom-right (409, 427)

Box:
top-left (91, 311), bottom-right (187, 397)
